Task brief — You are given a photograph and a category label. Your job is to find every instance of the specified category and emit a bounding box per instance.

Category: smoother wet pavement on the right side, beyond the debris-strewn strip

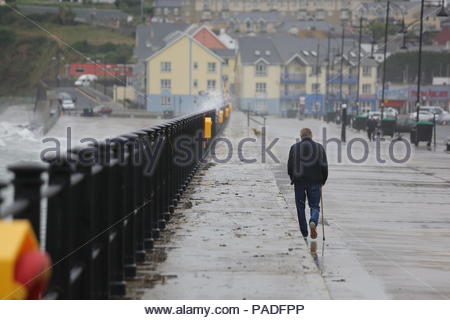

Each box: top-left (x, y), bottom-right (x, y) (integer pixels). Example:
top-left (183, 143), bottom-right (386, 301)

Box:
top-left (267, 118), bottom-right (450, 299)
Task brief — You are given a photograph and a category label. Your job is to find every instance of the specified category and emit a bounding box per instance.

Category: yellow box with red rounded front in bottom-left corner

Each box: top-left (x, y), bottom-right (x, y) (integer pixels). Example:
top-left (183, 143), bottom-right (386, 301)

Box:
top-left (0, 220), bottom-right (50, 300)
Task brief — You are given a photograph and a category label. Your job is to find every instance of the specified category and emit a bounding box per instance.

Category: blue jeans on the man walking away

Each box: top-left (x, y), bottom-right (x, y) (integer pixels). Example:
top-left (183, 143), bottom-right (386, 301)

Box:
top-left (294, 182), bottom-right (320, 237)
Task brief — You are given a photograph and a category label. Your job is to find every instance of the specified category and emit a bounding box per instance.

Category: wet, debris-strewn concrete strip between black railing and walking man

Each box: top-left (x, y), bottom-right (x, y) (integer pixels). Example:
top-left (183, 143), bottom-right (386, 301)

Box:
top-left (137, 112), bottom-right (330, 299)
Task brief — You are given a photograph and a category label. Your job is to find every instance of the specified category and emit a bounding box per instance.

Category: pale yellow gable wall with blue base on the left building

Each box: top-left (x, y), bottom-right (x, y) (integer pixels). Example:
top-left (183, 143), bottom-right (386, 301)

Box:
top-left (146, 33), bottom-right (224, 113)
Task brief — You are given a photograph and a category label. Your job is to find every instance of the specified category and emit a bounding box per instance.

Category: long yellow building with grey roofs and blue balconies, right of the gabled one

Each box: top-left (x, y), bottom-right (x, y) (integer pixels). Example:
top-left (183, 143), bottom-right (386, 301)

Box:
top-left (236, 35), bottom-right (377, 115)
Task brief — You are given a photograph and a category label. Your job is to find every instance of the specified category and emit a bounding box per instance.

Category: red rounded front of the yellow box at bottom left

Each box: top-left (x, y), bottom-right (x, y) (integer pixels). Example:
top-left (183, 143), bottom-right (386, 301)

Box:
top-left (15, 249), bottom-right (51, 300)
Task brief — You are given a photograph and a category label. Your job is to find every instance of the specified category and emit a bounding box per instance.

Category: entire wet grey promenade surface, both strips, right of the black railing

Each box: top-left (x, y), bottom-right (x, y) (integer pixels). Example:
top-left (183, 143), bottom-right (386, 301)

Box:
top-left (131, 112), bottom-right (450, 299)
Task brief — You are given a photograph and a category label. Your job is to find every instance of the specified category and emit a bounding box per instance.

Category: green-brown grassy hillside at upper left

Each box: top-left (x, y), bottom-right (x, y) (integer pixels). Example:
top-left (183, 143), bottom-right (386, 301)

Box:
top-left (0, 7), bottom-right (134, 96)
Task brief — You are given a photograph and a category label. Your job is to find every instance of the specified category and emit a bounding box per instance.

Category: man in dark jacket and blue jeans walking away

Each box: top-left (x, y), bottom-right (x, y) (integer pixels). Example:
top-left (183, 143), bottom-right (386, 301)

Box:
top-left (288, 128), bottom-right (328, 239)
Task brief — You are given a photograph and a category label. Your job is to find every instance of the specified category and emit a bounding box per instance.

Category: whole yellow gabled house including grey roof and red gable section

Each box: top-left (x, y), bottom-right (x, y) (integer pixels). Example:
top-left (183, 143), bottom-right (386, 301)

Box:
top-left (134, 23), bottom-right (236, 113)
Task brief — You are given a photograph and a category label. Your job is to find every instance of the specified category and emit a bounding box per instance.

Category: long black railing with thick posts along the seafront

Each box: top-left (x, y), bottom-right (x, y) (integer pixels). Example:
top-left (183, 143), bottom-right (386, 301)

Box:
top-left (0, 107), bottom-right (228, 299)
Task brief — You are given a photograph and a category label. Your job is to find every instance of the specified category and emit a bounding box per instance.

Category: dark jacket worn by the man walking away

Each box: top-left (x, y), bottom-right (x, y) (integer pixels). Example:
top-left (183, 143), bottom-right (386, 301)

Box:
top-left (288, 138), bottom-right (328, 184)
